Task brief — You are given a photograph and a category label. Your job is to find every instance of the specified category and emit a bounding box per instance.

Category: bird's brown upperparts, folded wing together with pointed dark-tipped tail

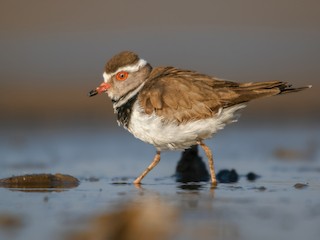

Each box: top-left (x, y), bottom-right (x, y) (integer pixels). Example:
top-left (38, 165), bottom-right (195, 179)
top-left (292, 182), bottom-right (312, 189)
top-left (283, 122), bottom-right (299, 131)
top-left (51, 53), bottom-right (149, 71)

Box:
top-left (139, 67), bottom-right (308, 123)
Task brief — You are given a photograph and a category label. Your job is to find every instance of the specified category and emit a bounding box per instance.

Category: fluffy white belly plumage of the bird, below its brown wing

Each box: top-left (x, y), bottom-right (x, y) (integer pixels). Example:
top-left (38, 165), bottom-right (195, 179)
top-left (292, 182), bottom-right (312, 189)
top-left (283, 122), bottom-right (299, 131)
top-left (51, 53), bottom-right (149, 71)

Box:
top-left (128, 102), bottom-right (245, 150)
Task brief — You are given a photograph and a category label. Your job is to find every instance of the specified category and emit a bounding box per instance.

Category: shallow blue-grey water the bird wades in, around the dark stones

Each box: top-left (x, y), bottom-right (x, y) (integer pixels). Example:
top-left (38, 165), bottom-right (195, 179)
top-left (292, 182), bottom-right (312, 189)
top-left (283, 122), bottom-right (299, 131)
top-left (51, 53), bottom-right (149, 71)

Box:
top-left (0, 124), bottom-right (320, 239)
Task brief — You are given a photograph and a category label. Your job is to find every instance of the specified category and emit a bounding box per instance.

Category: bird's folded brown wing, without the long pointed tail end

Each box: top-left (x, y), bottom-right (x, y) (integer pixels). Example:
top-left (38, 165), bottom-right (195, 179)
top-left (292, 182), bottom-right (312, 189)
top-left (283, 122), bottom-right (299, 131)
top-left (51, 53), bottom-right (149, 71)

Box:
top-left (139, 67), bottom-right (238, 123)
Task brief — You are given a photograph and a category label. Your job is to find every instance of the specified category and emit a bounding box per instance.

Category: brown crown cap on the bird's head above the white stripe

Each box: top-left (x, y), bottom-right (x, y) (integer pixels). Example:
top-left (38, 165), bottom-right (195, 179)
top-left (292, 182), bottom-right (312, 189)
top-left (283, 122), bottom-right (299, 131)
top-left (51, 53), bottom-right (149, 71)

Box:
top-left (105, 51), bottom-right (139, 73)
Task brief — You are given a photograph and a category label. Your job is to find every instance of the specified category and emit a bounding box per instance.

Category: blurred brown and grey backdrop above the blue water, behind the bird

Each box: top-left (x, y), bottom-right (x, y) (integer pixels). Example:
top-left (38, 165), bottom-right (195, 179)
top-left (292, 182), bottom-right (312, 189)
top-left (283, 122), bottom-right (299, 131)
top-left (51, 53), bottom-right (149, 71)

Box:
top-left (0, 0), bottom-right (320, 127)
